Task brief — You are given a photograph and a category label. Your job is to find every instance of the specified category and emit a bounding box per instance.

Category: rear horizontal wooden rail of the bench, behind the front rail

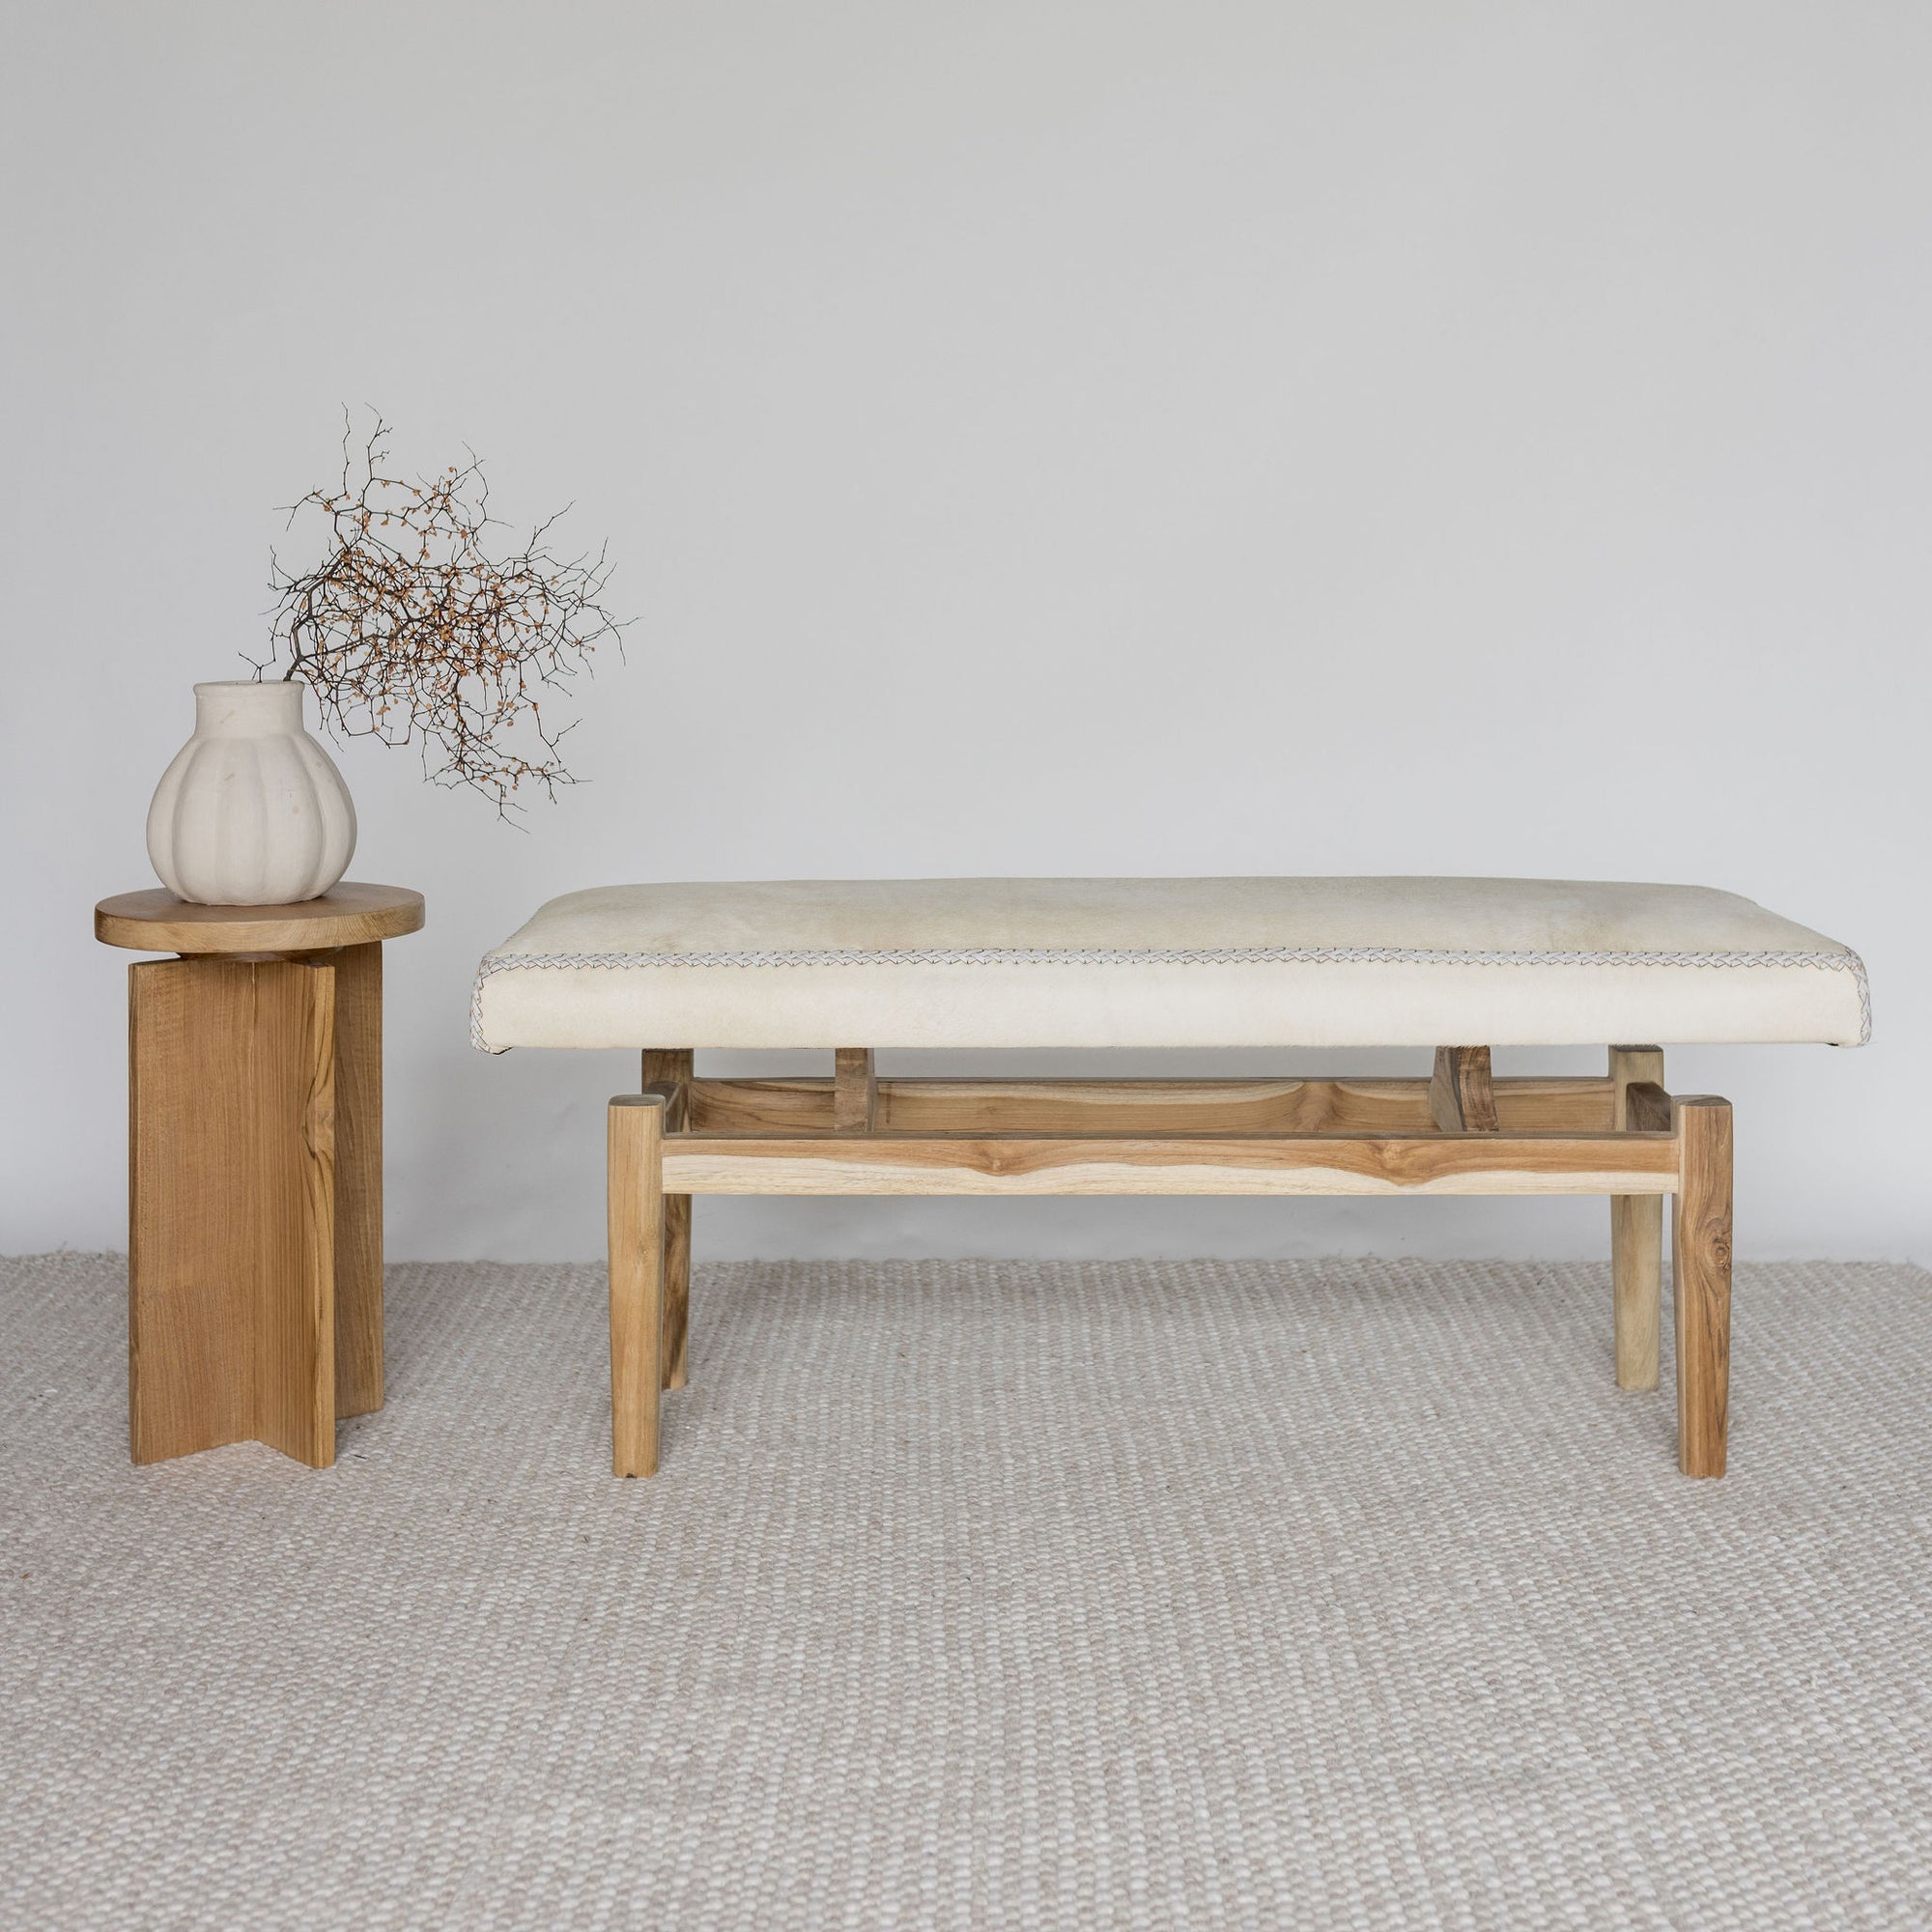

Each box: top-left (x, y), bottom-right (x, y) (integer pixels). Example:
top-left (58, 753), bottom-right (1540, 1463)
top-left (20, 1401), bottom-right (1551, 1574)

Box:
top-left (690, 1078), bottom-right (1615, 1134)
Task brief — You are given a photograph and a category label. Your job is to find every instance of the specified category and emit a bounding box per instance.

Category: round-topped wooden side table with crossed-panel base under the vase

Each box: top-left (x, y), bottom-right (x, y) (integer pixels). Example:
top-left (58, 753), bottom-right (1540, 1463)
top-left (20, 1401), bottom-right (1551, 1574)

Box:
top-left (95, 879), bottom-right (423, 1468)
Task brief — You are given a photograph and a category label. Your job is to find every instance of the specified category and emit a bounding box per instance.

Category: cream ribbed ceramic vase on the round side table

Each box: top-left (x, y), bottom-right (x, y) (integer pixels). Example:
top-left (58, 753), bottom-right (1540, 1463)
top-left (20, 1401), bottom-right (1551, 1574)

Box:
top-left (147, 682), bottom-right (355, 906)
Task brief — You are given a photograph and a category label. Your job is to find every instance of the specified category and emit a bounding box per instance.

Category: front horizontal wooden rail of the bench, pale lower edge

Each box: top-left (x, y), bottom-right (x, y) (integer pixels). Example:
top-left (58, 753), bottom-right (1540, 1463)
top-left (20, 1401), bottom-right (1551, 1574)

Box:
top-left (663, 1134), bottom-right (1677, 1194)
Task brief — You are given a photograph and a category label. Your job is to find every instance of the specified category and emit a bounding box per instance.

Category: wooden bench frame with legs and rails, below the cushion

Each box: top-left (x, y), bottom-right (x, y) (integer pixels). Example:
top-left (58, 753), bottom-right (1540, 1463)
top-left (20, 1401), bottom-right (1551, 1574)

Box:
top-left (609, 1047), bottom-right (1731, 1476)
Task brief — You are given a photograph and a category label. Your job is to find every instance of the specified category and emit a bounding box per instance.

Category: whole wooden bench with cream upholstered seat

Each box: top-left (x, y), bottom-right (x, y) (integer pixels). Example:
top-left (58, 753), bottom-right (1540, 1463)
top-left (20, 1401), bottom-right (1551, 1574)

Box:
top-left (471, 879), bottom-right (1870, 1476)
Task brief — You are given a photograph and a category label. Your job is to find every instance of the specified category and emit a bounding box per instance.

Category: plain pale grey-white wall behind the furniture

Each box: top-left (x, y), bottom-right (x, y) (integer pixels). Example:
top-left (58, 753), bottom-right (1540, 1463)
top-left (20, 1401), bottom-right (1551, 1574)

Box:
top-left (0, 0), bottom-right (1932, 1260)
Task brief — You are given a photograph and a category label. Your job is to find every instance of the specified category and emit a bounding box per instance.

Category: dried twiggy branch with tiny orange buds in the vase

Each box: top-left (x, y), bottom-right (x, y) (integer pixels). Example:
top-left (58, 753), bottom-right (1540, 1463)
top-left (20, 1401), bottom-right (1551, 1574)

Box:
top-left (243, 417), bottom-right (622, 815)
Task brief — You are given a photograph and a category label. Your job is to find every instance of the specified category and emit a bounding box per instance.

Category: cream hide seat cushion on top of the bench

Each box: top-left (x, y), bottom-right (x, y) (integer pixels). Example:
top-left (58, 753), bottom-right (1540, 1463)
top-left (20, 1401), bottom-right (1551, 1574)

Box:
top-left (473, 879), bottom-right (1868, 1051)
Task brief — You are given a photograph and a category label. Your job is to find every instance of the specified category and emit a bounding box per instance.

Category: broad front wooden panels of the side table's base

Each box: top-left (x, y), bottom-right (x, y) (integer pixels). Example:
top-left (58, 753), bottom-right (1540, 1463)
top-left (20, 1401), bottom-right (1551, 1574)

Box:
top-left (128, 958), bottom-right (336, 1468)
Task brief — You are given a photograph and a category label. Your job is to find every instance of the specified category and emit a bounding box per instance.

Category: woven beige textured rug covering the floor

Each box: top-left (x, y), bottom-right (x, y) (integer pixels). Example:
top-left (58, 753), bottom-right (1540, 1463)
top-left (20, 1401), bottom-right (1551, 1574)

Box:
top-left (0, 1256), bottom-right (1932, 1932)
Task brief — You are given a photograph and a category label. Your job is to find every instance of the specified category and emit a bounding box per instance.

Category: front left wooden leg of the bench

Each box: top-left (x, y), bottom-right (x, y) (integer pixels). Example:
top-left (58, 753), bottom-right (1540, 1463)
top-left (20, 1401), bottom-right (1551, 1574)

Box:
top-left (607, 1094), bottom-right (665, 1476)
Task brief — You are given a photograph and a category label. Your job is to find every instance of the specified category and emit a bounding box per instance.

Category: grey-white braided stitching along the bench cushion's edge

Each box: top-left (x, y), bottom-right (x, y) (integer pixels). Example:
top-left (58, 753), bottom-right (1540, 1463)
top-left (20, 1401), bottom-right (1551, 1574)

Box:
top-left (469, 947), bottom-right (1872, 1053)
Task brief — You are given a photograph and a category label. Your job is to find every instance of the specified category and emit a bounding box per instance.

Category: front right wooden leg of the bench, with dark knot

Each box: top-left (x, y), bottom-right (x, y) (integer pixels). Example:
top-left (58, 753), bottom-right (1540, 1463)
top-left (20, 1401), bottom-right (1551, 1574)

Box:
top-left (1671, 1095), bottom-right (1731, 1476)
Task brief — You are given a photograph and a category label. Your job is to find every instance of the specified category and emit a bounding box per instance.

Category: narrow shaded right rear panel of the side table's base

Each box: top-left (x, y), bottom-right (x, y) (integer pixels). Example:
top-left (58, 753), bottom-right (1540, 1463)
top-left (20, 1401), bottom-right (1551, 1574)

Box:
top-left (330, 941), bottom-right (383, 1418)
